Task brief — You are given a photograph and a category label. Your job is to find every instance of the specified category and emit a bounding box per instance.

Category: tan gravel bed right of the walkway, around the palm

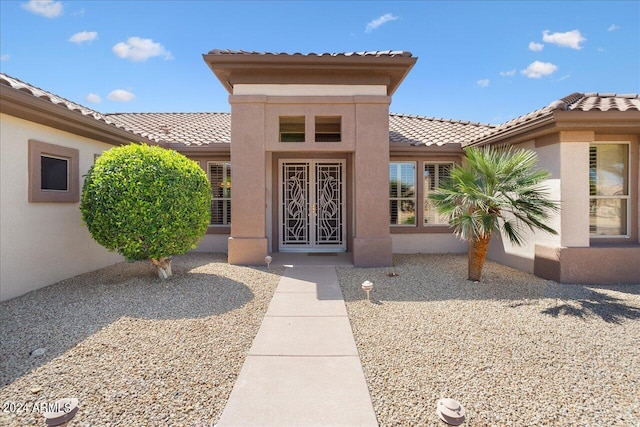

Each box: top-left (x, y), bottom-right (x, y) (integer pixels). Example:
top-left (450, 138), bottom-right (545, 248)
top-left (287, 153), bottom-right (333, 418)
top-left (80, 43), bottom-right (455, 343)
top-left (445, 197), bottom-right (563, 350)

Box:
top-left (337, 255), bottom-right (640, 426)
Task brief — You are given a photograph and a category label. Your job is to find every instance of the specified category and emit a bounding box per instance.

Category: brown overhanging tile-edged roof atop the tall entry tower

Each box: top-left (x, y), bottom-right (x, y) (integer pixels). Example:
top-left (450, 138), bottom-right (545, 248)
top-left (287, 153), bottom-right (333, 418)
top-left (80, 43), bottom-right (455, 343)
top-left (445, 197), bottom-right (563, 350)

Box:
top-left (202, 49), bottom-right (418, 96)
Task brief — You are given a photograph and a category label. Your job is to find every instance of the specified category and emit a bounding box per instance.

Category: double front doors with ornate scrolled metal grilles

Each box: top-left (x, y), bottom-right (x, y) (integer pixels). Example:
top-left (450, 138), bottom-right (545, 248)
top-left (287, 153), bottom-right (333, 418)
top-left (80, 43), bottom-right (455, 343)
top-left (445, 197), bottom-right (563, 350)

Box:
top-left (278, 160), bottom-right (347, 252)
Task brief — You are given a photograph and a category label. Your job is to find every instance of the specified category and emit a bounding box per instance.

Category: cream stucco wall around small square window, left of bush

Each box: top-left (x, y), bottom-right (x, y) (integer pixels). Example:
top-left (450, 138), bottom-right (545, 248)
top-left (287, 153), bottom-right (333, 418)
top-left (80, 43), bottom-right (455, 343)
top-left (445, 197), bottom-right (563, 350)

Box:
top-left (0, 114), bottom-right (122, 300)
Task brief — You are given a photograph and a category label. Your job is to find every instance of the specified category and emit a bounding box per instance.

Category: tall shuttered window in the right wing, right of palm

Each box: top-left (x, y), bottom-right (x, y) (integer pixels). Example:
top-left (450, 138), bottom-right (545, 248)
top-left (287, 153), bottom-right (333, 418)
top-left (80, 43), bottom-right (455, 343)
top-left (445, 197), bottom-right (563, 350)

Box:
top-left (589, 143), bottom-right (629, 237)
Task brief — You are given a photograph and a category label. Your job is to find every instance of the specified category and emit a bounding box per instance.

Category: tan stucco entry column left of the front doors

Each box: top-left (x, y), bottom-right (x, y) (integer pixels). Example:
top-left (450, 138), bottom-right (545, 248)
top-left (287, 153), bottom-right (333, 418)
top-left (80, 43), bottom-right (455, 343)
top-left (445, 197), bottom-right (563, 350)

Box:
top-left (228, 95), bottom-right (267, 265)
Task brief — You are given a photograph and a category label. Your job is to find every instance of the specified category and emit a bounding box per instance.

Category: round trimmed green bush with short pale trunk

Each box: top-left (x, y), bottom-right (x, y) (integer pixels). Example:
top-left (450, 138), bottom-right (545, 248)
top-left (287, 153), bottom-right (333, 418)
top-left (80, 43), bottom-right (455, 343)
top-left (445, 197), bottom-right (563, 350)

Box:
top-left (80, 144), bottom-right (211, 277)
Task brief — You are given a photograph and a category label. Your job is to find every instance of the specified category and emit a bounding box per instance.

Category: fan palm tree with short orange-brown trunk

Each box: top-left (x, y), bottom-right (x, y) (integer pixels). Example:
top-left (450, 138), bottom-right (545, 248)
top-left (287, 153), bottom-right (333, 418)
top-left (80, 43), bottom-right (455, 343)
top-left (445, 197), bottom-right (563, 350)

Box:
top-left (429, 147), bottom-right (559, 281)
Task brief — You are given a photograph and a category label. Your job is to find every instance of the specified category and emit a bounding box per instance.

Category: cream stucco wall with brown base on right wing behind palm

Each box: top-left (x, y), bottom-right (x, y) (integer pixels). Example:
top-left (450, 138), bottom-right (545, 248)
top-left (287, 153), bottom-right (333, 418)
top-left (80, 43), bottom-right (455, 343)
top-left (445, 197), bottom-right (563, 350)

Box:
top-left (488, 131), bottom-right (640, 283)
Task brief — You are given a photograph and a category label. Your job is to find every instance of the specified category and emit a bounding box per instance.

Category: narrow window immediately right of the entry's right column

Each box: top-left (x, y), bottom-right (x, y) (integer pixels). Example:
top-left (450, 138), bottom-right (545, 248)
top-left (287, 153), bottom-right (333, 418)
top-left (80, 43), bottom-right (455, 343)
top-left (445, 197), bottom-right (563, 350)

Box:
top-left (389, 162), bottom-right (416, 226)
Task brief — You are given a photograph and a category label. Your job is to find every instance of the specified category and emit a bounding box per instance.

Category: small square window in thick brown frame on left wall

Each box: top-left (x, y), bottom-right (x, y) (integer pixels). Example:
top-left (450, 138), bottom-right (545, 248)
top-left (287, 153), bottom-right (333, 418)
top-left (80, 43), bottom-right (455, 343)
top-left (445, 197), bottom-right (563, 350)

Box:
top-left (29, 140), bottom-right (80, 203)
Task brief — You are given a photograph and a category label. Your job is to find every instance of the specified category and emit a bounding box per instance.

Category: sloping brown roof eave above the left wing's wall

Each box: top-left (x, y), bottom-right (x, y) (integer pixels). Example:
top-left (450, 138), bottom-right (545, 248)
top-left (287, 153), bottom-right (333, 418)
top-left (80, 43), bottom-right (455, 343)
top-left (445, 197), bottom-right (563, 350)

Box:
top-left (0, 76), bottom-right (164, 145)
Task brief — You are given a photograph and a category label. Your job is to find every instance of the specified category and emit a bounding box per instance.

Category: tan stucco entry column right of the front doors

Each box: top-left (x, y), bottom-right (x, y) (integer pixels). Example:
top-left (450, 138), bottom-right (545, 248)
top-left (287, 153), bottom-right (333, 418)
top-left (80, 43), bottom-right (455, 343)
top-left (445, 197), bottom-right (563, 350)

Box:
top-left (353, 96), bottom-right (392, 267)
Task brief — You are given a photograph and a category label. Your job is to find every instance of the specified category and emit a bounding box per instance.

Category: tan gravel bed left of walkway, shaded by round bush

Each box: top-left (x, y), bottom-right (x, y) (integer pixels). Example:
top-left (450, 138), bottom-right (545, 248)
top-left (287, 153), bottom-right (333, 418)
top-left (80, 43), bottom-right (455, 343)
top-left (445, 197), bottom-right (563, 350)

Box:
top-left (0, 254), bottom-right (282, 427)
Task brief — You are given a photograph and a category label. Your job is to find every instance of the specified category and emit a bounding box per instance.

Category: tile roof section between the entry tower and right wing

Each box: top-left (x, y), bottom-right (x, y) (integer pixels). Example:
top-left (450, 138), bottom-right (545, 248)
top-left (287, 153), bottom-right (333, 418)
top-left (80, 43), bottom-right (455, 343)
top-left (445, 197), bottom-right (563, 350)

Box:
top-left (389, 113), bottom-right (495, 146)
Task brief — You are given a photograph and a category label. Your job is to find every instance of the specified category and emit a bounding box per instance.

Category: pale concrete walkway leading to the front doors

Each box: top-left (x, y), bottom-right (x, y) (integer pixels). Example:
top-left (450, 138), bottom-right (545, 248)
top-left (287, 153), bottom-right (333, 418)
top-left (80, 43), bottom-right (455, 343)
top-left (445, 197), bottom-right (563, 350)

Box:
top-left (217, 266), bottom-right (378, 427)
